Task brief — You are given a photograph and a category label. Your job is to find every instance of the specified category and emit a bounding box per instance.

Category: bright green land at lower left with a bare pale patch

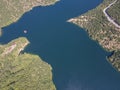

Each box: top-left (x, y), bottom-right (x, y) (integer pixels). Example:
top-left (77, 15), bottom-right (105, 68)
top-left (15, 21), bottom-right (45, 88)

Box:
top-left (0, 38), bottom-right (55, 90)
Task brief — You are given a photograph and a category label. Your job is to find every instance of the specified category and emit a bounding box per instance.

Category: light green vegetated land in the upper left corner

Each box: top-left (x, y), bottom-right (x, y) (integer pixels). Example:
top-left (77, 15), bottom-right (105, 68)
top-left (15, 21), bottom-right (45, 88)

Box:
top-left (0, 0), bottom-right (58, 35)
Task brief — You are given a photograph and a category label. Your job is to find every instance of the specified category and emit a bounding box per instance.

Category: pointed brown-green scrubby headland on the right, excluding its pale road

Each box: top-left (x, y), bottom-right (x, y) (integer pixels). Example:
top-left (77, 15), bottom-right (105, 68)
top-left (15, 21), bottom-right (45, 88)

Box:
top-left (68, 0), bottom-right (120, 71)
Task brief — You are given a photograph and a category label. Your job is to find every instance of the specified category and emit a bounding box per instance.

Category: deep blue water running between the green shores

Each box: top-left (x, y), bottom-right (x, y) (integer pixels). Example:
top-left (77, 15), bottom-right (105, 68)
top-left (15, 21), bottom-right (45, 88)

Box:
top-left (0, 0), bottom-right (120, 90)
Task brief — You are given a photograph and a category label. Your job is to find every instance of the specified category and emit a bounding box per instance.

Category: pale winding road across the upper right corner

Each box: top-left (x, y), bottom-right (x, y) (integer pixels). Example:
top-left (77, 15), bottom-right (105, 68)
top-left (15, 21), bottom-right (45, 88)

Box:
top-left (103, 0), bottom-right (120, 28)
